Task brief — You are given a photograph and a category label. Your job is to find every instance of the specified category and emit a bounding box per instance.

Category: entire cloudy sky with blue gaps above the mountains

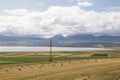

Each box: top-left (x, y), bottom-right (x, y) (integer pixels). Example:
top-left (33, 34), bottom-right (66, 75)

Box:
top-left (0, 0), bottom-right (120, 37)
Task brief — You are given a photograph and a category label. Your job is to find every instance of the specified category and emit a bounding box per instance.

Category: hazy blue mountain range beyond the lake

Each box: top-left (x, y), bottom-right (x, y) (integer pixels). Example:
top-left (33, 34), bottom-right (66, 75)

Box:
top-left (0, 34), bottom-right (120, 47)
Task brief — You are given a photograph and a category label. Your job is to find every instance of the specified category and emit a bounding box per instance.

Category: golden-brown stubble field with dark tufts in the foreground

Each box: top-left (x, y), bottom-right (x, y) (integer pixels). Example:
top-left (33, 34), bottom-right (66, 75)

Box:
top-left (0, 59), bottom-right (120, 80)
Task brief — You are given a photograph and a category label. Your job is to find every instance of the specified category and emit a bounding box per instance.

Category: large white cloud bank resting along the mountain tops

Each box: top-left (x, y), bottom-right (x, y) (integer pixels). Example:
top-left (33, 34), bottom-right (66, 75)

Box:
top-left (0, 6), bottom-right (120, 37)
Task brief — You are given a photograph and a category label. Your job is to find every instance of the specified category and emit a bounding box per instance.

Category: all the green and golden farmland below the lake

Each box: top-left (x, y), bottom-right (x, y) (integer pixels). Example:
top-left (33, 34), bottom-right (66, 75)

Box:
top-left (0, 50), bottom-right (120, 80)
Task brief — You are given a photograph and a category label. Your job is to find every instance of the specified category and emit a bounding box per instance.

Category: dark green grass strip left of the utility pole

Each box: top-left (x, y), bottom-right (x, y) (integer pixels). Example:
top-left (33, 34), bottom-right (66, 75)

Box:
top-left (0, 56), bottom-right (48, 63)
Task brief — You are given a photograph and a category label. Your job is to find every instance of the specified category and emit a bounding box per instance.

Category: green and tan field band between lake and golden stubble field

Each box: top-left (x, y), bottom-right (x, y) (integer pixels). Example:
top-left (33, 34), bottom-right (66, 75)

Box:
top-left (0, 50), bottom-right (120, 64)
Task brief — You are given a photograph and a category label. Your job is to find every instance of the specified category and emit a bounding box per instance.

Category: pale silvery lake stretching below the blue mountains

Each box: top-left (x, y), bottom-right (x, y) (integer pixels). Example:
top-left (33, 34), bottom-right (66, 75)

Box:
top-left (0, 46), bottom-right (110, 52)
